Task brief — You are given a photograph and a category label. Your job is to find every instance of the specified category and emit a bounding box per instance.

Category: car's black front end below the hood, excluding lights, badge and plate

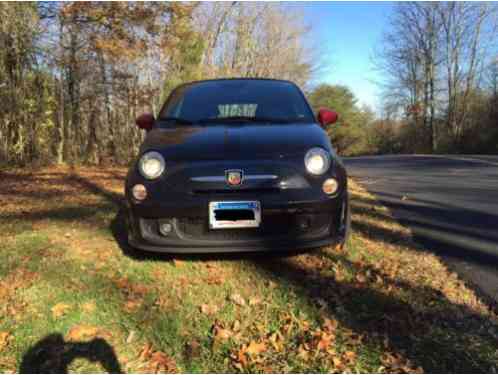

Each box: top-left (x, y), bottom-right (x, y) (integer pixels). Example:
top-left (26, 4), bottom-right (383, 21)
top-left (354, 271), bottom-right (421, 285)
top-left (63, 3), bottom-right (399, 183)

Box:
top-left (126, 155), bottom-right (347, 253)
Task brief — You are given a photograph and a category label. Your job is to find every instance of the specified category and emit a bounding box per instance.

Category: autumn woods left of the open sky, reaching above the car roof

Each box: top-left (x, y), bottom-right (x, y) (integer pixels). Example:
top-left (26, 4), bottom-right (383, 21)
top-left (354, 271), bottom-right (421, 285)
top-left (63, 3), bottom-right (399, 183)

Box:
top-left (0, 2), bottom-right (313, 164)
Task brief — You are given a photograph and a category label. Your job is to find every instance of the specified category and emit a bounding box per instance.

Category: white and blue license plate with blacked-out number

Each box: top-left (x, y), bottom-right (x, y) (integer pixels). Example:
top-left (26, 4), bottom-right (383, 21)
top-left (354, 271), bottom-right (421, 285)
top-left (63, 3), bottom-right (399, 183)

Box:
top-left (209, 201), bottom-right (261, 229)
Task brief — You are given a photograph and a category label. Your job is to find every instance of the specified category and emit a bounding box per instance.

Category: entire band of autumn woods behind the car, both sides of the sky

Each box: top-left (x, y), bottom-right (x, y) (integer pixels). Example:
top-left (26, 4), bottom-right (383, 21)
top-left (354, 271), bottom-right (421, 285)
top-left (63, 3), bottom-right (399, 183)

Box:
top-left (0, 1), bottom-right (498, 165)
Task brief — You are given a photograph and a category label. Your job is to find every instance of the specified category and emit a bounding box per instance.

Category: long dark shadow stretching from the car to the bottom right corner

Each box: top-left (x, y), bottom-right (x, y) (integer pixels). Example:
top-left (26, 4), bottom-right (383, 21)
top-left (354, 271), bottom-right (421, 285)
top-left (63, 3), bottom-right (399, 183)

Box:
top-left (251, 252), bottom-right (498, 372)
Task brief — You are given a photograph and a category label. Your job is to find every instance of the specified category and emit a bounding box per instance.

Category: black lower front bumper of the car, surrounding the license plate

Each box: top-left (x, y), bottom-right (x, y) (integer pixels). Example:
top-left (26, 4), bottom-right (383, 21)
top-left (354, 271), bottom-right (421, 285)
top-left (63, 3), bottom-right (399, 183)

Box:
top-left (127, 193), bottom-right (347, 253)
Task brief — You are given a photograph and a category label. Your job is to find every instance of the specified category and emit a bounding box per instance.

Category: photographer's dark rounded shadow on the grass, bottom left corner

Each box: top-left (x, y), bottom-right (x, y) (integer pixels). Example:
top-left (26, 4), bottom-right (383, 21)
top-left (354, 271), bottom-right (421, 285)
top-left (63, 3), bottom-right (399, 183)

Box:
top-left (19, 333), bottom-right (122, 374)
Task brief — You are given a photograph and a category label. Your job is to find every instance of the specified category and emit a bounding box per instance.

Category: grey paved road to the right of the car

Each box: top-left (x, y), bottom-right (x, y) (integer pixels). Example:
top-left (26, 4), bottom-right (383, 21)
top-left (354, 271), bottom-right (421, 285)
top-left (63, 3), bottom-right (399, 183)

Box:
top-left (344, 155), bottom-right (498, 306)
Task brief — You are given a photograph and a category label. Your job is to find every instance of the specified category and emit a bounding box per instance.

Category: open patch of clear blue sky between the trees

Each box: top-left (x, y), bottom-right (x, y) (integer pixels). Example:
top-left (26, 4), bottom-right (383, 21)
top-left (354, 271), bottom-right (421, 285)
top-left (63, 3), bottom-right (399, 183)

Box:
top-left (299, 1), bottom-right (394, 111)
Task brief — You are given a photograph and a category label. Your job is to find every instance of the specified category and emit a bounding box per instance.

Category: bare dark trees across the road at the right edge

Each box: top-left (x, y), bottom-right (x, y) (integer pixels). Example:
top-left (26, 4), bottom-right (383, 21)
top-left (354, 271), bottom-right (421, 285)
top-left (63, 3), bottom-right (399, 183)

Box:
top-left (373, 2), bottom-right (498, 153)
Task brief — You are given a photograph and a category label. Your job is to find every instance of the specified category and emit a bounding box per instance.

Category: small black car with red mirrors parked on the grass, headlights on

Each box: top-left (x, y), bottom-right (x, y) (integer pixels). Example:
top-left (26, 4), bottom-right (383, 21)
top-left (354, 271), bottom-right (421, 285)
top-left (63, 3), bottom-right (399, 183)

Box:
top-left (125, 79), bottom-right (350, 253)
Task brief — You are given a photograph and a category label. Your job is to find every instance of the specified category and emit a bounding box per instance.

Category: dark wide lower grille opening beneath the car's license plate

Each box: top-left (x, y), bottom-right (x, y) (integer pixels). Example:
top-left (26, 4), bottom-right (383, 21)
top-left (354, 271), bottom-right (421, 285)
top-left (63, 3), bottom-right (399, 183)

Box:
top-left (177, 214), bottom-right (331, 241)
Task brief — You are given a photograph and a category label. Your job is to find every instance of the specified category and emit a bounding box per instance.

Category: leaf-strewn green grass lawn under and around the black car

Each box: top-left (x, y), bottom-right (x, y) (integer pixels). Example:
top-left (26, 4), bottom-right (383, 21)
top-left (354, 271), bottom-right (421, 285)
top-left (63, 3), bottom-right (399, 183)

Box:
top-left (0, 168), bottom-right (498, 372)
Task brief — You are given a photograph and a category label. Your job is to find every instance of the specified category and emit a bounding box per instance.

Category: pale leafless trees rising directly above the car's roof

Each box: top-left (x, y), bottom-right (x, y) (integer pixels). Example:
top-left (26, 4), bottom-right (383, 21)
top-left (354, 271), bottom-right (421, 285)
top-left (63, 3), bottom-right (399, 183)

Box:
top-left (196, 2), bottom-right (314, 86)
